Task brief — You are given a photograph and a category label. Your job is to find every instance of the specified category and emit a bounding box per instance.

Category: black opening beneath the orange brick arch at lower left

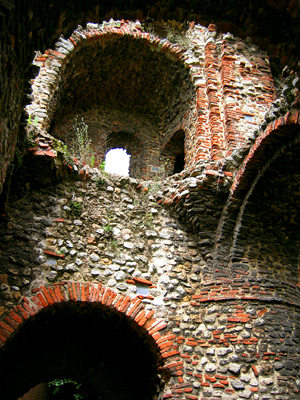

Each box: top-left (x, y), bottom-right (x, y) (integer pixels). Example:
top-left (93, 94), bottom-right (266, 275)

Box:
top-left (0, 301), bottom-right (161, 400)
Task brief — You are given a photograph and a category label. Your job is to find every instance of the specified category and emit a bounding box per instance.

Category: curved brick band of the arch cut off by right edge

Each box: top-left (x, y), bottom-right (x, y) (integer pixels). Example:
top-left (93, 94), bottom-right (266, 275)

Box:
top-left (214, 110), bottom-right (300, 276)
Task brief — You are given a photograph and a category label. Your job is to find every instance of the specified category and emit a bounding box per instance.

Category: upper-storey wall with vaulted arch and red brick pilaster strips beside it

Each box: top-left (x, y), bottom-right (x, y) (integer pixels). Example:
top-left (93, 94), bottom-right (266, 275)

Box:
top-left (26, 20), bottom-right (274, 179)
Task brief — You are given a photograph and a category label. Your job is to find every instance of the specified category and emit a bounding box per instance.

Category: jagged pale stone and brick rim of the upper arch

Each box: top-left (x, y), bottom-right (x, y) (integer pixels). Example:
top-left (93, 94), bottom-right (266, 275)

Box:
top-left (26, 20), bottom-right (191, 132)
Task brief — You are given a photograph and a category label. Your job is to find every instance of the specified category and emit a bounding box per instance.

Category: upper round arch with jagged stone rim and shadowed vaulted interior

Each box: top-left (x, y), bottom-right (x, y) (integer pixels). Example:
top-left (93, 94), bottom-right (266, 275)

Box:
top-left (26, 21), bottom-right (199, 179)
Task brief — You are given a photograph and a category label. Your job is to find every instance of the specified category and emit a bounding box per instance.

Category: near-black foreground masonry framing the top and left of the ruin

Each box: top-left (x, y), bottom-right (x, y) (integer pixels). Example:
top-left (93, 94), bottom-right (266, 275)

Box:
top-left (0, 0), bottom-right (299, 195)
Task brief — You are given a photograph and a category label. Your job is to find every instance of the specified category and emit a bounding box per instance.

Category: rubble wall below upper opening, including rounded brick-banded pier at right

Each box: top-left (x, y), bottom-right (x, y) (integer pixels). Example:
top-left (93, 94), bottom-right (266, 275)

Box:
top-left (0, 175), bottom-right (300, 400)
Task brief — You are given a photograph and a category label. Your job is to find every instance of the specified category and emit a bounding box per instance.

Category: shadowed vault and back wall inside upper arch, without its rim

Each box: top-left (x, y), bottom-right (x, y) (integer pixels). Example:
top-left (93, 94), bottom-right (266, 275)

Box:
top-left (41, 25), bottom-right (196, 180)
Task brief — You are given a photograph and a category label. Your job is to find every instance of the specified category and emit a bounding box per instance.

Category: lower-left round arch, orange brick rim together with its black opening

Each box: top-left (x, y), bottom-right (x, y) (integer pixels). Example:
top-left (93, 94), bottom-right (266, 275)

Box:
top-left (0, 282), bottom-right (178, 400)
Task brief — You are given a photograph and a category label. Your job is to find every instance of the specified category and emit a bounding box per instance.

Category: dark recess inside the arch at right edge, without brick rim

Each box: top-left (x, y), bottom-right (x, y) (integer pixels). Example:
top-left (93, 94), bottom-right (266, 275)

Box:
top-left (232, 141), bottom-right (300, 284)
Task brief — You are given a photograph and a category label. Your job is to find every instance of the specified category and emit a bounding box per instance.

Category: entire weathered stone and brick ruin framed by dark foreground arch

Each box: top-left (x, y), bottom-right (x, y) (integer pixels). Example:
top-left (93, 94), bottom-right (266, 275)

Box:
top-left (0, 14), bottom-right (300, 400)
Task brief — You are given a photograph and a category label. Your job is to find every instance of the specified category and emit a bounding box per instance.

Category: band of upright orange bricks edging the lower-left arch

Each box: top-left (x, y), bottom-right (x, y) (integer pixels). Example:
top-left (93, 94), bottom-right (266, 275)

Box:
top-left (0, 282), bottom-right (183, 398)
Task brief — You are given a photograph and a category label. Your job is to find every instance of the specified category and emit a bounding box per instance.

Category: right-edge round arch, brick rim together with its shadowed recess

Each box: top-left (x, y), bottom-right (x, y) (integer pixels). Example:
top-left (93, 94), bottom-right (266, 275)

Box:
top-left (214, 110), bottom-right (300, 284)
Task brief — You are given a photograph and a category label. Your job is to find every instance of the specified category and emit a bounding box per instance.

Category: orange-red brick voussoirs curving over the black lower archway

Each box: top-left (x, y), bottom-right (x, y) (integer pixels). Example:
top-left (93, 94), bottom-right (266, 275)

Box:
top-left (0, 282), bottom-right (172, 346)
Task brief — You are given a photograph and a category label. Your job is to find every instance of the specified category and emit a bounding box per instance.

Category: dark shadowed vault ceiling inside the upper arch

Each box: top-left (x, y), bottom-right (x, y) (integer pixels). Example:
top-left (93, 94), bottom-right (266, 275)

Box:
top-left (54, 35), bottom-right (193, 125)
